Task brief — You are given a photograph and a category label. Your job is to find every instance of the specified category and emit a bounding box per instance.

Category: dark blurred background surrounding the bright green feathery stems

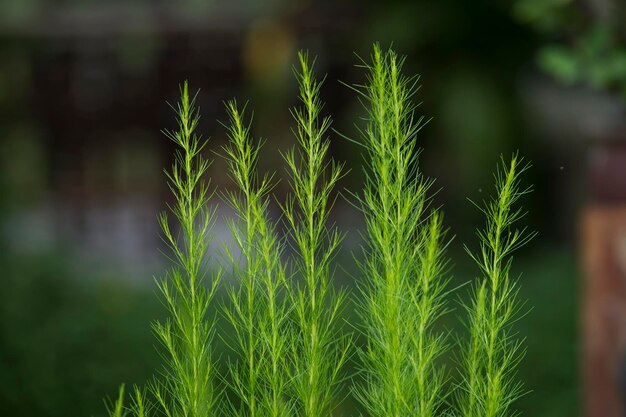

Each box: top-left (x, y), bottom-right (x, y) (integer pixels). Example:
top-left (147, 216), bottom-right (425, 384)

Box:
top-left (0, 0), bottom-right (626, 417)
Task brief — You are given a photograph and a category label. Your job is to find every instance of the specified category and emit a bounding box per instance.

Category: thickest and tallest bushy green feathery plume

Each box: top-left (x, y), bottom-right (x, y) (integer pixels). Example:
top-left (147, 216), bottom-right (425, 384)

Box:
top-left (354, 45), bottom-right (447, 417)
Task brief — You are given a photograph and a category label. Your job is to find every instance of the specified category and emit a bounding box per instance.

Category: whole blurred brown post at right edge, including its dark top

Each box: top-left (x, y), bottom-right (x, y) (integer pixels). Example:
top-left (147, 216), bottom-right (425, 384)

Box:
top-left (581, 140), bottom-right (626, 417)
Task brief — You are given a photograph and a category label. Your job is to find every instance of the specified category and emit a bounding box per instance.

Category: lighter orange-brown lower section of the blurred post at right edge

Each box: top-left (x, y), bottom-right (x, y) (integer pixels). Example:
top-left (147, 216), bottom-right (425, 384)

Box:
top-left (583, 206), bottom-right (626, 417)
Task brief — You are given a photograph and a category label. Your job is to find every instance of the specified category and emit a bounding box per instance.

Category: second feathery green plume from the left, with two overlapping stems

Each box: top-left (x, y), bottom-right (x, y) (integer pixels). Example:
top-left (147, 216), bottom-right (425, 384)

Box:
top-left (224, 101), bottom-right (291, 417)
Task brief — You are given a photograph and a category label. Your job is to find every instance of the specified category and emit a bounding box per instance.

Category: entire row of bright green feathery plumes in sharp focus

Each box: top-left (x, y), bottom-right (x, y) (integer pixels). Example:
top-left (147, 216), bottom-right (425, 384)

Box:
top-left (102, 45), bottom-right (532, 417)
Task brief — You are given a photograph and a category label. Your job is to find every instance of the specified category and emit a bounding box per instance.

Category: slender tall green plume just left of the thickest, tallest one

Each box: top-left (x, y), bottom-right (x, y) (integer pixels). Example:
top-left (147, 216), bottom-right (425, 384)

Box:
top-left (283, 52), bottom-right (351, 417)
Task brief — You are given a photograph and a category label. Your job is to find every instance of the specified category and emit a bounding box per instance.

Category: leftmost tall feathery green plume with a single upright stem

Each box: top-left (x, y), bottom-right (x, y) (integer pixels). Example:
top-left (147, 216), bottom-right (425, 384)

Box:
top-left (152, 82), bottom-right (221, 417)
